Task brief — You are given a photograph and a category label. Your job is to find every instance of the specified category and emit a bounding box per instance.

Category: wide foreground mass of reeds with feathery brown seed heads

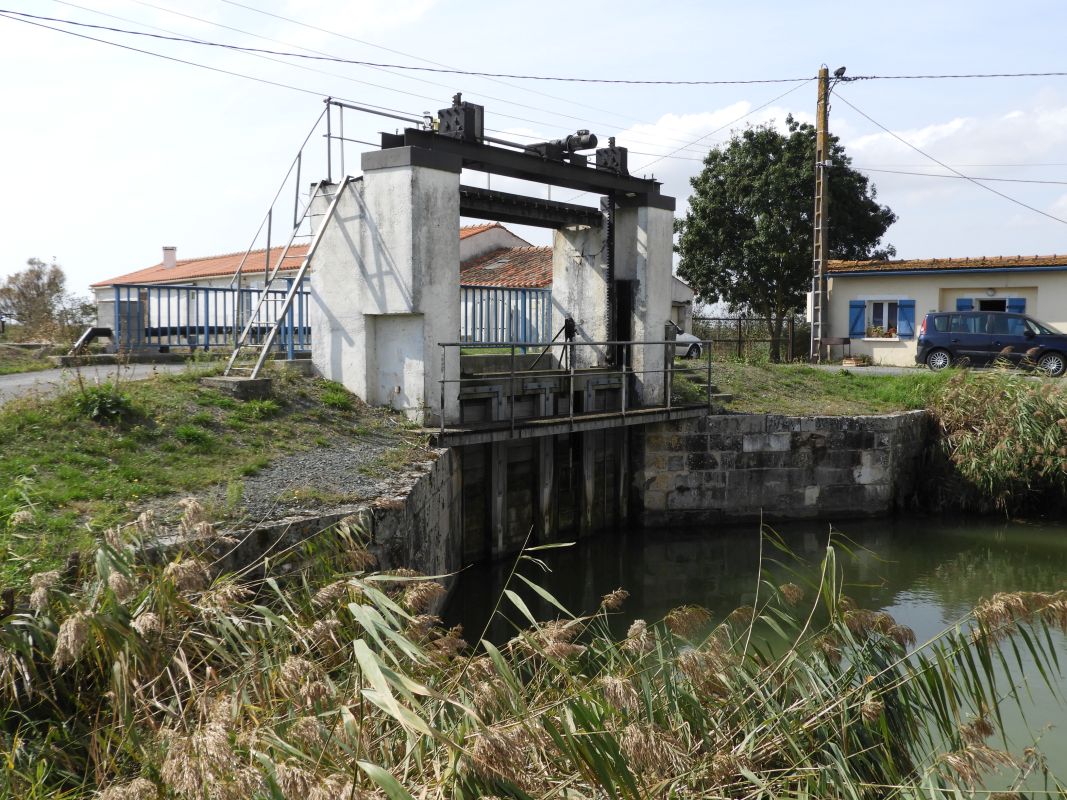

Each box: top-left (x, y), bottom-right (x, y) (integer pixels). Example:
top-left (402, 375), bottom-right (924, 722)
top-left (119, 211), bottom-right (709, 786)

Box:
top-left (0, 502), bottom-right (1067, 800)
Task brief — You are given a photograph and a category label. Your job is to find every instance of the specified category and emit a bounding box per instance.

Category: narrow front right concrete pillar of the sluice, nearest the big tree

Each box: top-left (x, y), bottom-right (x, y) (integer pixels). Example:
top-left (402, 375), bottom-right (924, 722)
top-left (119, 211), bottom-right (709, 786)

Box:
top-left (615, 194), bottom-right (674, 405)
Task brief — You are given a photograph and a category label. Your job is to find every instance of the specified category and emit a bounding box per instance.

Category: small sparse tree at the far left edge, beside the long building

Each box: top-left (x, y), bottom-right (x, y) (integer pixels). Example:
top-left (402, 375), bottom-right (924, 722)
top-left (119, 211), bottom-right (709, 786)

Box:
top-left (0, 258), bottom-right (92, 338)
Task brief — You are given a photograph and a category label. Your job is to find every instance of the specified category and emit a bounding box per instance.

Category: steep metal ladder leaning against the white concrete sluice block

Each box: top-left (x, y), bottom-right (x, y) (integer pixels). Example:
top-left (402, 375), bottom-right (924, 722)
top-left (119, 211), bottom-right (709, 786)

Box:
top-left (223, 178), bottom-right (352, 378)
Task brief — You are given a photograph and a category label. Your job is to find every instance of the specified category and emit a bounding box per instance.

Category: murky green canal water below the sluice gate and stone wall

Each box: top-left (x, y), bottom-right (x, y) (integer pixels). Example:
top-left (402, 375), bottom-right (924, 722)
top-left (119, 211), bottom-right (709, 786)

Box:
top-left (445, 517), bottom-right (1067, 788)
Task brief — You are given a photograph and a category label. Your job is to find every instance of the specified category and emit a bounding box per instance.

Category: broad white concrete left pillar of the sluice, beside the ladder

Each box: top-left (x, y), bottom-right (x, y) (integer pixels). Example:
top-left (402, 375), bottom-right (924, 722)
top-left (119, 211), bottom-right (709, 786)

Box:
top-left (309, 147), bottom-right (460, 423)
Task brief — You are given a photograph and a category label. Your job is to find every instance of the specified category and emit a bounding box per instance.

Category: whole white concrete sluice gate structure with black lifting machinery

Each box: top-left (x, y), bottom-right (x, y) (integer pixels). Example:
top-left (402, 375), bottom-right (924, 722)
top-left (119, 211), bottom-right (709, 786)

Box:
top-left (308, 98), bottom-right (707, 562)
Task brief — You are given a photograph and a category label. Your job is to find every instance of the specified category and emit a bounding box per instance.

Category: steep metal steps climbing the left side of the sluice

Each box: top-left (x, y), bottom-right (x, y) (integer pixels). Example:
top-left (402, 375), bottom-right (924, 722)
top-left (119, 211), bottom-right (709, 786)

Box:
top-left (223, 177), bottom-right (352, 378)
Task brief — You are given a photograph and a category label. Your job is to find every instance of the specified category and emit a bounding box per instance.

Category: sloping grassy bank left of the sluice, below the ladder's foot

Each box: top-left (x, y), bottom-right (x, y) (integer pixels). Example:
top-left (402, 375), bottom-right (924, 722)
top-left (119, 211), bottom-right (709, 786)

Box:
top-left (0, 373), bottom-right (422, 582)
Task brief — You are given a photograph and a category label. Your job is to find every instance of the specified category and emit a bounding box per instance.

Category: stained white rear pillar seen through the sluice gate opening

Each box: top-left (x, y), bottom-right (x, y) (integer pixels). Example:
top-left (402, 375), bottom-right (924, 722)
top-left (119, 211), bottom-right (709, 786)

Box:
top-left (552, 220), bottom-right (607, 368)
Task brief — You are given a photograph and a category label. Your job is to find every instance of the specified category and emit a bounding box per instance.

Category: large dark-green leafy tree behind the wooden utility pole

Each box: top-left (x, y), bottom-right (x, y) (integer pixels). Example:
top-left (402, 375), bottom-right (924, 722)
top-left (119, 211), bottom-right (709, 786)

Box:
top-left (675, 115), bottom-right (896, 361)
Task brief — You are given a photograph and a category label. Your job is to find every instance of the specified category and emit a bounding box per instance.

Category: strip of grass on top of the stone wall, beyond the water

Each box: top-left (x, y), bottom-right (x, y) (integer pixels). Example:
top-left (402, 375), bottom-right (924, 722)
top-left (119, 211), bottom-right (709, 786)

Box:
top-left (712, 362), bottom-right (956, 415)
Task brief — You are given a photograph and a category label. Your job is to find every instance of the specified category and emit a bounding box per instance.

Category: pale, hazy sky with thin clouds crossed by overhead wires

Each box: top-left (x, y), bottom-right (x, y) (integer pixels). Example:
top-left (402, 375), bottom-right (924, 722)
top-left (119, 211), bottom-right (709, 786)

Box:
top-left (0, 0), bottom-right (1067, 293)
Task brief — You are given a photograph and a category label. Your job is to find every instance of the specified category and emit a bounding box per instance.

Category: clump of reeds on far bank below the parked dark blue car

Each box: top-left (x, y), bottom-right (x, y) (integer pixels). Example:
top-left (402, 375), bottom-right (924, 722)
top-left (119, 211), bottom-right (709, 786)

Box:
top-left (930, 370), bottom-right (1067, 512)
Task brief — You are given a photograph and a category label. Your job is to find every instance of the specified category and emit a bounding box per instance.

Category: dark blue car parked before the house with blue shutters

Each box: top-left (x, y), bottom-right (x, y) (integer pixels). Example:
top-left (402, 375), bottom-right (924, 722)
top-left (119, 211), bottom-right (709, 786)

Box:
top-left (915, 311), bottom-right (1067, 378)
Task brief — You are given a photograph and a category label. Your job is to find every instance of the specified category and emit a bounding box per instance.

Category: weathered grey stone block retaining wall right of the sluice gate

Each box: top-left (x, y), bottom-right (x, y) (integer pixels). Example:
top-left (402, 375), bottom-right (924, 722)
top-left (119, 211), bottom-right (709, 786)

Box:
top-left (634, 412), bottom-right (930, 525)
